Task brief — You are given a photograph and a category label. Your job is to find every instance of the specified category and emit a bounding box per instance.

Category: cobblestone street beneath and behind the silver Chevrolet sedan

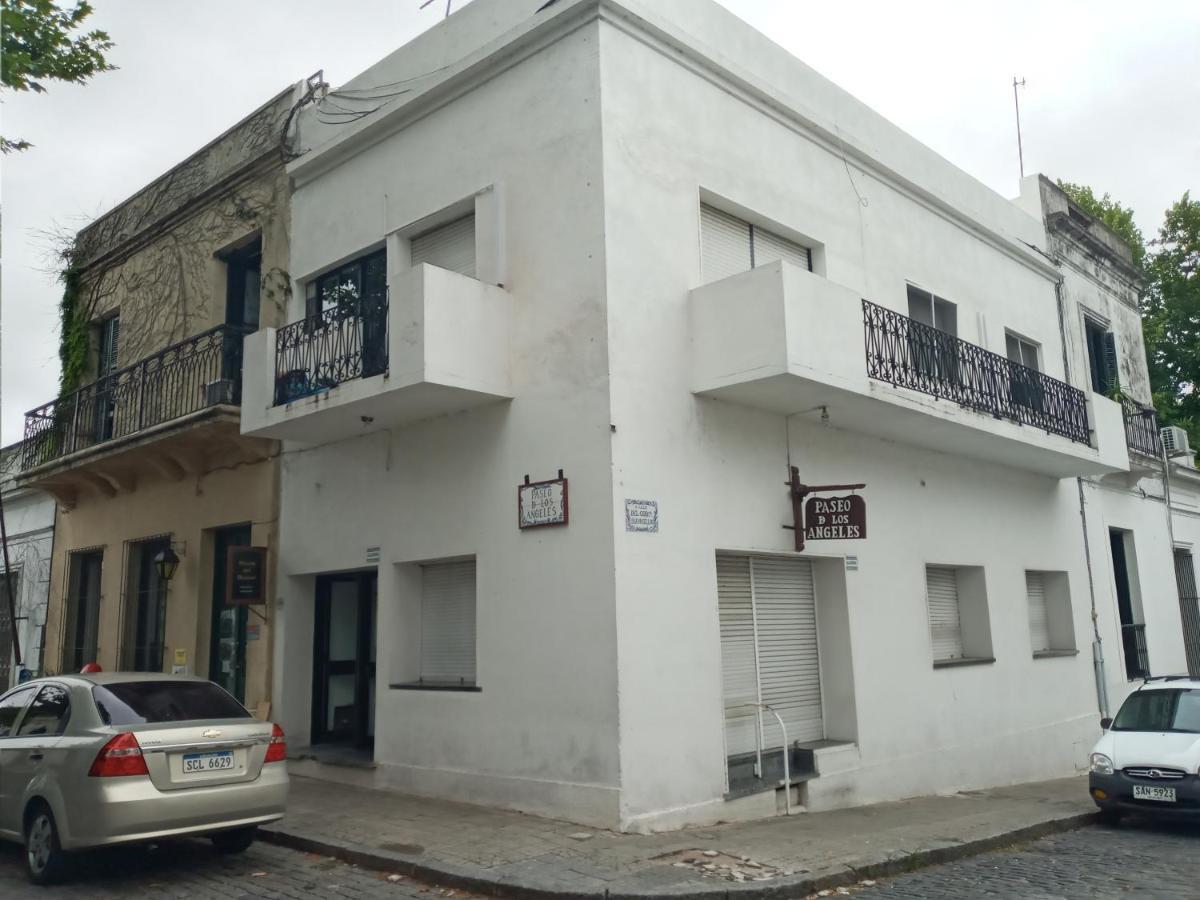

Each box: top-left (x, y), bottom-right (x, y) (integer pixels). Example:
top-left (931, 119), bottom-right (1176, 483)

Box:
top-left (0, 840), bottom-right (487, 900)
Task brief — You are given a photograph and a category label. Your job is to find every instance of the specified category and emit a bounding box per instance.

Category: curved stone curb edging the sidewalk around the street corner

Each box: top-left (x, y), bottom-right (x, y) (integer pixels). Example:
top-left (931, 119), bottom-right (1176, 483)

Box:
top-left (258, 812), bottom-right (1097, 900)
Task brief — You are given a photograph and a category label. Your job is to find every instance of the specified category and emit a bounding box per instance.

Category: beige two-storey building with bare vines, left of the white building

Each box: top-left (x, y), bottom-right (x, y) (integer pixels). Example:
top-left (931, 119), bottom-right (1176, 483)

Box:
top-left (19, 84), bottom-right (306, 708)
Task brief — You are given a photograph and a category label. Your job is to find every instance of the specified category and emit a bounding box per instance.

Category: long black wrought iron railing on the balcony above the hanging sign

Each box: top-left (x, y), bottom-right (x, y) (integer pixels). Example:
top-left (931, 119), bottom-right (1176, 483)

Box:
top-left (863, 300), bottom-right (1091, 444)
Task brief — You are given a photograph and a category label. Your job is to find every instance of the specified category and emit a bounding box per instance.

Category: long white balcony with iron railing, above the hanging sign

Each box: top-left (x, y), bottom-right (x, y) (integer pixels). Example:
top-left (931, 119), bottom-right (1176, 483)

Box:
top-left (690, 263), bottom-right (1129, 478)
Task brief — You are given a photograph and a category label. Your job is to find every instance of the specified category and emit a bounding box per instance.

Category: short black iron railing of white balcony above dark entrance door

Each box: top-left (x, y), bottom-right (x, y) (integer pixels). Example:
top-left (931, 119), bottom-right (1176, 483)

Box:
top-left (275, 294), bottom-right (388, 406)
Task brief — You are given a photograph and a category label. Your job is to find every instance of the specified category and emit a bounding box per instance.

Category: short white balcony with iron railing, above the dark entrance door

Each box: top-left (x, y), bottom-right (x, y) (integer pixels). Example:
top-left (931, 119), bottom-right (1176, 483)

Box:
top-left (241, 265), bottom-right (512, 443)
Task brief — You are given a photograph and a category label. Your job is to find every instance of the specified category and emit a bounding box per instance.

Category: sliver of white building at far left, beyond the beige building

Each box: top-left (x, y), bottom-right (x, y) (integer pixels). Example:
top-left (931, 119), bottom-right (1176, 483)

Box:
top-left (0, 444), bottom-right (54, 691)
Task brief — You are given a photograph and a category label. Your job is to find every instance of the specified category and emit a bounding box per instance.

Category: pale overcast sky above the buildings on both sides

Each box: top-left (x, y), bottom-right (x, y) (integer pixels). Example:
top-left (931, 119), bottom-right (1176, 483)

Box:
top-left (0, 0), bottom-right (1200, 444)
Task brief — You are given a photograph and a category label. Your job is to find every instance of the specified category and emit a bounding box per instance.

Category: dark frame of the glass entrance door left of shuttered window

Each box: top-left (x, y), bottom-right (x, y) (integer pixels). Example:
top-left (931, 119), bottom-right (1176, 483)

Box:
top-left (311, 578), bottom-right (378, 746)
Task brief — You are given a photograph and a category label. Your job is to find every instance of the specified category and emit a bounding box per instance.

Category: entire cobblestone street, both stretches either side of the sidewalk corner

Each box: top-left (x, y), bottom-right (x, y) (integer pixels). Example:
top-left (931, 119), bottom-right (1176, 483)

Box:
top-left (0, 822), bottom-right (1200, 900)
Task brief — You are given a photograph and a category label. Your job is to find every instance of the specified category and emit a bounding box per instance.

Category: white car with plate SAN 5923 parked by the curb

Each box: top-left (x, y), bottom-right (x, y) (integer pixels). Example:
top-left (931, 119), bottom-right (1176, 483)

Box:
top-left (1088, 676), bottom-right (1200, 823)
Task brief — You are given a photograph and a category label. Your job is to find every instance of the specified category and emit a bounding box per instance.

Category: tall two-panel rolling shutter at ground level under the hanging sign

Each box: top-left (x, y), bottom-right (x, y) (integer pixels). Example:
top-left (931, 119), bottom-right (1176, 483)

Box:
top-left (716, 556), bottom-right (824, 756)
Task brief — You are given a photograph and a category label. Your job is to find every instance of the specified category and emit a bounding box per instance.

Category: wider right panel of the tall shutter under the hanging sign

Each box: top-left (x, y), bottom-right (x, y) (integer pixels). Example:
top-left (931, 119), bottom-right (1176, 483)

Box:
top-left (750, 557), bottom-right (824, 748)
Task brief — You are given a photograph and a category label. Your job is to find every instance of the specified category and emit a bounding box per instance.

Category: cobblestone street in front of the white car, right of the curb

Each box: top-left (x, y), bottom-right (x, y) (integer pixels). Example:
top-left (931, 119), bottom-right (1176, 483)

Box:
top-left (854, 821), bottom-right (1200, 900)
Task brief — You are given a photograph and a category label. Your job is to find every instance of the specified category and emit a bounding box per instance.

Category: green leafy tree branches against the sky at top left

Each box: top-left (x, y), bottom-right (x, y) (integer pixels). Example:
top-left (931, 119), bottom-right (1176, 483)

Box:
top-left (0, 0), bottom-right (114, 154)
